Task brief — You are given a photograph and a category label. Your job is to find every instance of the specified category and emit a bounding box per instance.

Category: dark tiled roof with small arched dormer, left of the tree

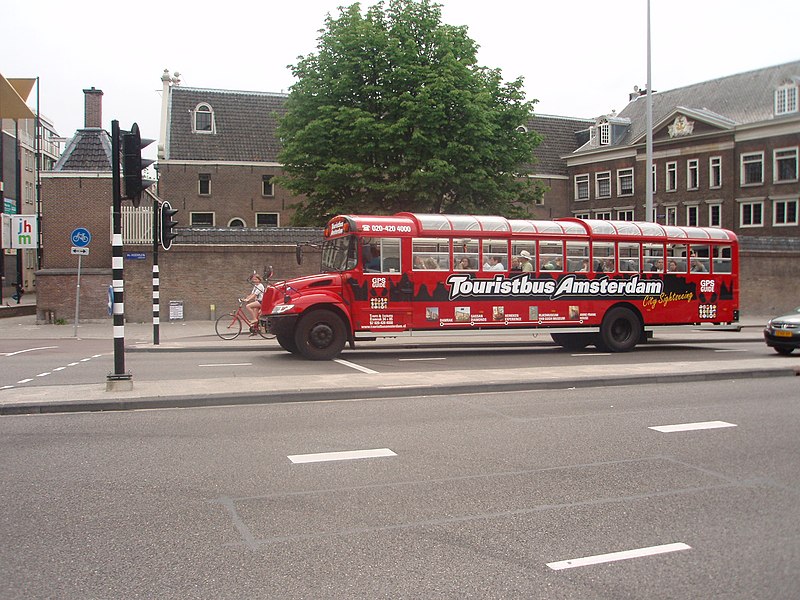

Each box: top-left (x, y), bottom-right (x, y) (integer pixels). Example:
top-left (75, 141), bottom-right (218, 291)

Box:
top-left (165, 86), bottom-right (287, 162)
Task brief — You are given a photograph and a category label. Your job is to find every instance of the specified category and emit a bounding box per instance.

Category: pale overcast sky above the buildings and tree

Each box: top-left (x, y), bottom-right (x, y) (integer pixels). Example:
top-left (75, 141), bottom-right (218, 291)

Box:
top-left (6, 0), bottom-right (800, 148)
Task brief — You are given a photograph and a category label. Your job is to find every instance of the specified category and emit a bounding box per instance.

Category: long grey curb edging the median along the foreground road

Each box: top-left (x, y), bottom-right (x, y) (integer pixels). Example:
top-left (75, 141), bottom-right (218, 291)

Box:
top-left (0, 367), bottom-right (800, 416)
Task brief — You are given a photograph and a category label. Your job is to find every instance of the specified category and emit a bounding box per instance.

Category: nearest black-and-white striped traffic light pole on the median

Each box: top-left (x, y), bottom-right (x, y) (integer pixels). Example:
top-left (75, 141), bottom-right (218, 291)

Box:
top-left (106, 121), bottom-right (133, 391)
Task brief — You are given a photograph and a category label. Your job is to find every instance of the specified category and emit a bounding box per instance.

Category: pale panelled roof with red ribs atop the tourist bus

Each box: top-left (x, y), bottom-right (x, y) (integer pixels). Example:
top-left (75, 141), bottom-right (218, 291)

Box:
top-left (326, 212), bottom-right (737, 242)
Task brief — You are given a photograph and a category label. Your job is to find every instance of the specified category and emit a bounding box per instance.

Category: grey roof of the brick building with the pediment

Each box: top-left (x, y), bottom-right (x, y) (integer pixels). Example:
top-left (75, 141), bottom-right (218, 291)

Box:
top-left (579, 61), bottom-right (800, 151)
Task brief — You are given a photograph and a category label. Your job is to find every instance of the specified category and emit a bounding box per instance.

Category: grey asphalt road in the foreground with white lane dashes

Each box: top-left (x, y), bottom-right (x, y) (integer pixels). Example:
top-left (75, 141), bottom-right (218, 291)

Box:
top-left (0, 377), bottom-right (800, 600)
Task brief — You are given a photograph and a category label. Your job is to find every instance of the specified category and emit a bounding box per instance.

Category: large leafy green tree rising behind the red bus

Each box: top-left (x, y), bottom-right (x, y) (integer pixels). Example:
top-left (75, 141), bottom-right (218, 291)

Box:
top-left (279, 0), bottom-right (542, 225)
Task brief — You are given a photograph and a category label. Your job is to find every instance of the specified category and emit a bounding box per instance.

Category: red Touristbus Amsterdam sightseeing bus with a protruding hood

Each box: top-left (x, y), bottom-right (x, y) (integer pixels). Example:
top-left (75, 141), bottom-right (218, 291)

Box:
top-left (261, 213), bottom-right (739, 360)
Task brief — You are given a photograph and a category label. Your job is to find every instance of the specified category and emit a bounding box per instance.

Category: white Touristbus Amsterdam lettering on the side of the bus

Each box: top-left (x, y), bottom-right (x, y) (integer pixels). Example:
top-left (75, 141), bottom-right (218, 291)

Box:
top-left (447, 273), bottom-right (664, 300)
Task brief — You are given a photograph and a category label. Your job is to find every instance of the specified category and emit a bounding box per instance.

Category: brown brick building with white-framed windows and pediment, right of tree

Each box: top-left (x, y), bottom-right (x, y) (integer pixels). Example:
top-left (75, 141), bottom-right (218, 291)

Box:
top-left (564, 61), bottom-right (800, 237)
